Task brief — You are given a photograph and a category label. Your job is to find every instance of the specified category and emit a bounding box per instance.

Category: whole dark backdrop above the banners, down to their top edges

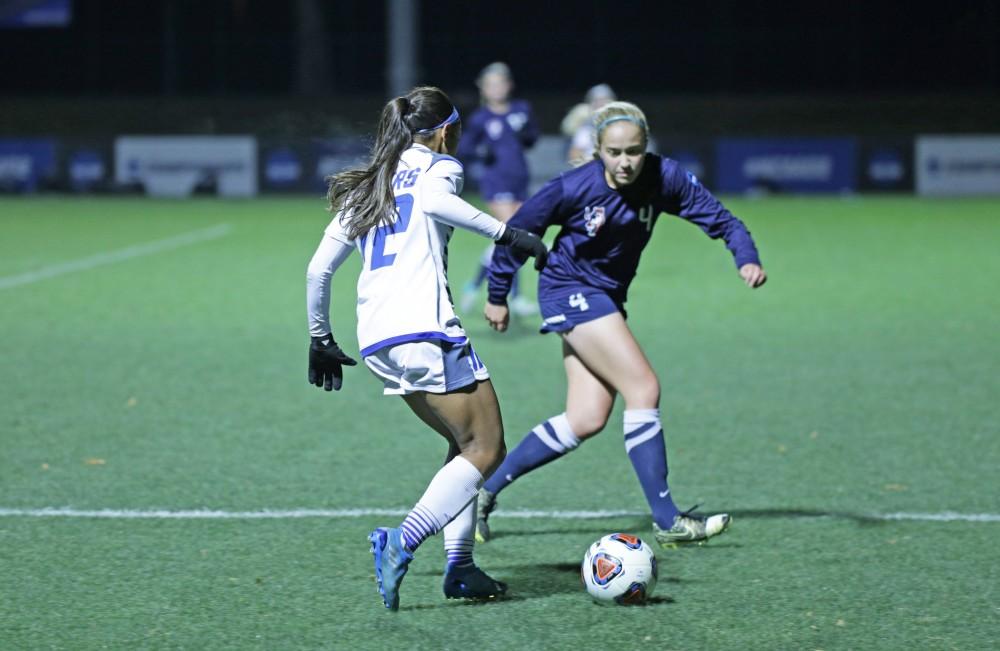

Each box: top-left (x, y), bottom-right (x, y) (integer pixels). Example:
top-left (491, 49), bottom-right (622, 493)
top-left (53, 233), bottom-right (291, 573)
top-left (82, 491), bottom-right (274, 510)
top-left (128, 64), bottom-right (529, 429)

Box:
top-left (0, 0), bottom-right (1000, 139)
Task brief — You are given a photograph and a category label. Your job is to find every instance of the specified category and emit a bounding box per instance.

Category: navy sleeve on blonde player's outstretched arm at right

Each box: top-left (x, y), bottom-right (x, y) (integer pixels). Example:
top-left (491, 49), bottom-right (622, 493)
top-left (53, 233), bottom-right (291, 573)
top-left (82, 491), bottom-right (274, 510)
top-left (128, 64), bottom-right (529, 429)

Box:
top-left (661, 159), bottom-right (760, 268)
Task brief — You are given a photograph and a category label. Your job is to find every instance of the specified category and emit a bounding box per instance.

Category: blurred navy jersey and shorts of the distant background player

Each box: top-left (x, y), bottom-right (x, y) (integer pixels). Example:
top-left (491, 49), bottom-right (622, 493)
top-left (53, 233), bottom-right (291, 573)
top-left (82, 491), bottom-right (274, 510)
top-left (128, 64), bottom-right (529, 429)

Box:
top-left (458, 100), bottom-right (538, 199)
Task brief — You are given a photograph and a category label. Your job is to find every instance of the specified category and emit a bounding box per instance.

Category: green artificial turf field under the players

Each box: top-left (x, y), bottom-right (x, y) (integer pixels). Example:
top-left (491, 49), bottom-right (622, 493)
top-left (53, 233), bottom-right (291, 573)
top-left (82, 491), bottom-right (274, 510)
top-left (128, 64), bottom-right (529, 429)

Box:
top-left (0, 198), bottom-right (1000, 650)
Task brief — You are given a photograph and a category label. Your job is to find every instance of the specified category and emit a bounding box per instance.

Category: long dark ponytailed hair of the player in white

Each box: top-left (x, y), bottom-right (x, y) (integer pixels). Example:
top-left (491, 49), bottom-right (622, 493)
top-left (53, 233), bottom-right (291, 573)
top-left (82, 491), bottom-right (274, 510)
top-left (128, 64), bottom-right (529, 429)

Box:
top-left (326, 86), bottom-right (454, 238)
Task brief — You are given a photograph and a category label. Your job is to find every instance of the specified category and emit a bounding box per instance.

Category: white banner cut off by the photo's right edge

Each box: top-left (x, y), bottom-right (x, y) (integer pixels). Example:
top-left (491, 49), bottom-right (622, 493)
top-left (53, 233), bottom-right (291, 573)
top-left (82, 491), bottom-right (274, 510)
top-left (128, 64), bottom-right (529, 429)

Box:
top-left (916, 135), bottom-right (1000, 196)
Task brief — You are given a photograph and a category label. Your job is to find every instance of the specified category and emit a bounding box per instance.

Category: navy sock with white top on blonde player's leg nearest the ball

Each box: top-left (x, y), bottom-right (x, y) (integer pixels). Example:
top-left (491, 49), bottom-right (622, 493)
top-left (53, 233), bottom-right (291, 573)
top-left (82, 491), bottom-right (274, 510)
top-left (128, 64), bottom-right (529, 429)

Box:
top-left (625, 409), bottom-right (680, 529)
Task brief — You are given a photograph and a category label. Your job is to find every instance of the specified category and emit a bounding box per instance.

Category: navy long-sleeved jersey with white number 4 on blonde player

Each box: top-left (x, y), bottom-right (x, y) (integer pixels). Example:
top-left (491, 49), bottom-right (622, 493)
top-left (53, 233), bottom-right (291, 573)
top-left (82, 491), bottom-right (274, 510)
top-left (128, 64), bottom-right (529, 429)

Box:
top-left (489, 154), bottom-right (760, 305)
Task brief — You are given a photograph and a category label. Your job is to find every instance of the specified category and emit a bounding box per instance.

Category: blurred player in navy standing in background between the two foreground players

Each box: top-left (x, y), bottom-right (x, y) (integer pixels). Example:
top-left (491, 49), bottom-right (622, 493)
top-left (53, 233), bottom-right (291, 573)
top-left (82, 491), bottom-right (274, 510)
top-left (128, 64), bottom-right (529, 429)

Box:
top-left (458, 62), bottom-right (538, 315)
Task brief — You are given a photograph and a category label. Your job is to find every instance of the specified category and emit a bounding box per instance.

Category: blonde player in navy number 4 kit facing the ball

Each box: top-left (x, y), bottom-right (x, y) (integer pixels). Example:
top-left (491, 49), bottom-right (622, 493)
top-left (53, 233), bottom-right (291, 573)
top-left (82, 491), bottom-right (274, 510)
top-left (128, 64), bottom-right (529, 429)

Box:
top-left (476, 102), bottom-right (767, 547)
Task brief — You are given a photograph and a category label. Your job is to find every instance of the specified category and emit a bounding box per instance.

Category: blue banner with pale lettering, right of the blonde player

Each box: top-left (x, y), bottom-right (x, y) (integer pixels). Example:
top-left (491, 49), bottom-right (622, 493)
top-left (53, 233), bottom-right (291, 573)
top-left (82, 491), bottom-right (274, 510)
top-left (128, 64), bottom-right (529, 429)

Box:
top-left (715, 138), bottom-right (857, 193)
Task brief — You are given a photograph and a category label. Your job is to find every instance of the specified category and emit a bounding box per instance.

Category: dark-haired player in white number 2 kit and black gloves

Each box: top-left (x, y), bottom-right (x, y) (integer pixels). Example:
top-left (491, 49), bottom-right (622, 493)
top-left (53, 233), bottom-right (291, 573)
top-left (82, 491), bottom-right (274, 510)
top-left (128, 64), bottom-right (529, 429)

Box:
top-left (306, 87), bottom-right (547, 610)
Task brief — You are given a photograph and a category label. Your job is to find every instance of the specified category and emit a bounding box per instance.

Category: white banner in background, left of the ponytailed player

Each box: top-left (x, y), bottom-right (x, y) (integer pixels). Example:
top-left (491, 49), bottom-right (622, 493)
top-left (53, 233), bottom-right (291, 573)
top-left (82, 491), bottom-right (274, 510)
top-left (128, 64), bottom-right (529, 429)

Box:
top-left (115, 136), bottom-right (257, 197)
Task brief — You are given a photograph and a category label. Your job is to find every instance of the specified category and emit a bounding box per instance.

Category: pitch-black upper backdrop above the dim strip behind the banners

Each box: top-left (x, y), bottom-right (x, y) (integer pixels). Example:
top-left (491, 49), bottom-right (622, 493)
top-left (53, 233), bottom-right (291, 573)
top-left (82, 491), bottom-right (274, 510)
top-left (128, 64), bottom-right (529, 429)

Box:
top-left (0, 0), bottom-right (1000, 95)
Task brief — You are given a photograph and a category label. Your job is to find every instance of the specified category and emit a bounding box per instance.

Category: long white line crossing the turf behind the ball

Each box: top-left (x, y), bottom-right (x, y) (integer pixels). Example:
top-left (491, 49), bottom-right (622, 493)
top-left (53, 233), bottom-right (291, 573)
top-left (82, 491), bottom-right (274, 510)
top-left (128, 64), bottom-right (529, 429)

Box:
top-left (0, 507), bottom-right (1000, 522)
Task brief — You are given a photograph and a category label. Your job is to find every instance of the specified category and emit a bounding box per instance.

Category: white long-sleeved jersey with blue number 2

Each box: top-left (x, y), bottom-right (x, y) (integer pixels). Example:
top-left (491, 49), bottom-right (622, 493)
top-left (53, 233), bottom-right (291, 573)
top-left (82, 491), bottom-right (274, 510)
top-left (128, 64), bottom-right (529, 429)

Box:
top-left (307, 145), bottom-right (505, 356)
